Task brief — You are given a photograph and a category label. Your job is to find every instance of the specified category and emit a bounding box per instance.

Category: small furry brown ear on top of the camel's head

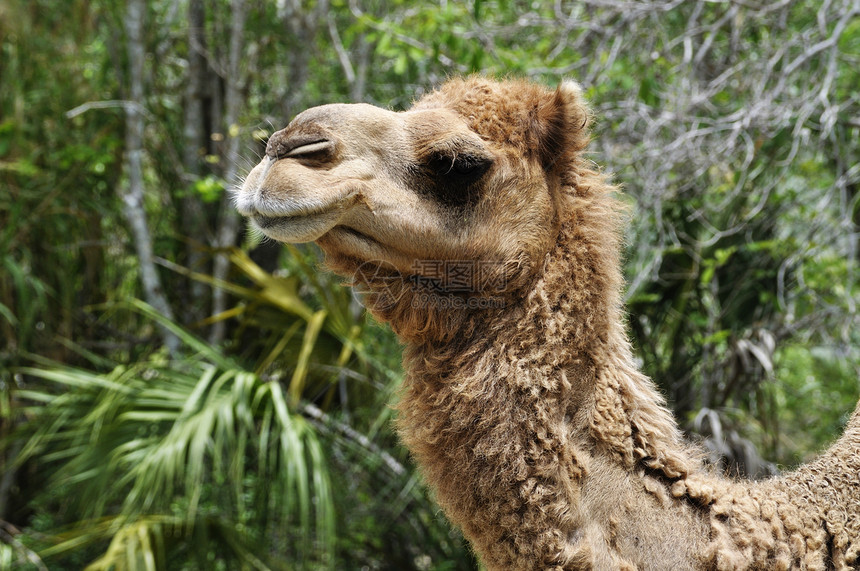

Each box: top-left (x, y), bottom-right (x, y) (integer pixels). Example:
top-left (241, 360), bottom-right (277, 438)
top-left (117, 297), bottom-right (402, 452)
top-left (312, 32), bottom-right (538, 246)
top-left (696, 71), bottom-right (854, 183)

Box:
top-left (532, 80), bottom-right (588, 170)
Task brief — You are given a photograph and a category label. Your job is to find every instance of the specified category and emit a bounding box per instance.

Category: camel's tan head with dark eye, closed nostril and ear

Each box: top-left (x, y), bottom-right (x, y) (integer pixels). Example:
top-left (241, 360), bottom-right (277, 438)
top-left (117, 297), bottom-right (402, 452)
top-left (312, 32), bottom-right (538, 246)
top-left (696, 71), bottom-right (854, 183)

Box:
top-left (236, 78), bottom-right (587, 342)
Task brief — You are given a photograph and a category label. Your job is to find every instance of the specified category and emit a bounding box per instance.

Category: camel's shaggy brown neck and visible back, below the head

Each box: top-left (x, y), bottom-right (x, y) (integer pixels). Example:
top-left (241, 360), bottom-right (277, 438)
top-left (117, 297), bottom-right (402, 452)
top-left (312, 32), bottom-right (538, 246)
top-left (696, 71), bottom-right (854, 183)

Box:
top-left (360, 165), bottom-right (860, 570)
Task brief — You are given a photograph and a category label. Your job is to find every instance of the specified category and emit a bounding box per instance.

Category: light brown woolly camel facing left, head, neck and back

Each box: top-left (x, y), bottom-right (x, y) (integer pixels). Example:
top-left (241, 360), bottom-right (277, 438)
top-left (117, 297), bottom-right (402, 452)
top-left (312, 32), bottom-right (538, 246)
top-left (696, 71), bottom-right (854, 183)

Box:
top-left (236, 77), bottom-right (860, 571)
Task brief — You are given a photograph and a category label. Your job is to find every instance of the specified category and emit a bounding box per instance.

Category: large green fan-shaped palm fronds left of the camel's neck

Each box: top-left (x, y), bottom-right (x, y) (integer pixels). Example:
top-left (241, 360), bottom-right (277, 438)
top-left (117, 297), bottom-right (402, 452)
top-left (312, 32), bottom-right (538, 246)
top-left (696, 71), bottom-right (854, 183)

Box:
top-left (18, 350), bottom-right (334, 569)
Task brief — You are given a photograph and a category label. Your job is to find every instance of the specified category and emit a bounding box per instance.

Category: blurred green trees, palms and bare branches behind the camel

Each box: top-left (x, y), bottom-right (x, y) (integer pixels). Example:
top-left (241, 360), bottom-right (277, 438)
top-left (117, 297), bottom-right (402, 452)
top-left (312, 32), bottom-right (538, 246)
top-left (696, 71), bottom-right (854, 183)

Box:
top-left (0, 0), bottom-right (860, 570)
